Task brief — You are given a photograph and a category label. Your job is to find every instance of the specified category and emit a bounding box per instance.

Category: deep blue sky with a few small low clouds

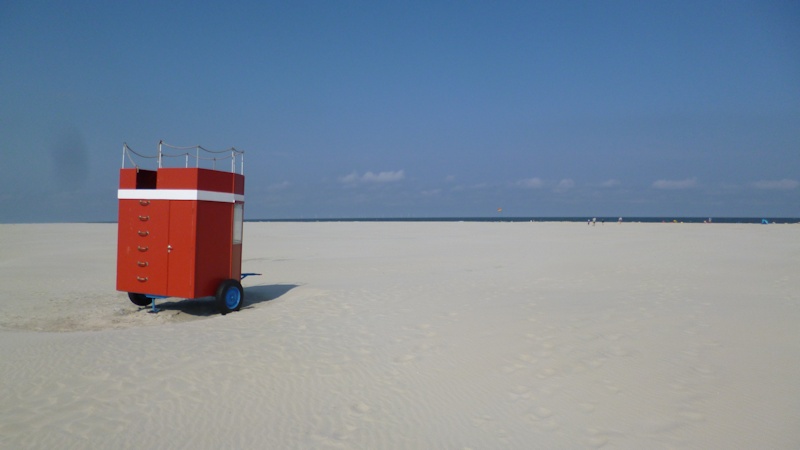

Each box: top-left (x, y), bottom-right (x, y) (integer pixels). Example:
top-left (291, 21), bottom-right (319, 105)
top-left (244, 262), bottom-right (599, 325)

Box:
top-left (0, 0), bottom-right (800, 222)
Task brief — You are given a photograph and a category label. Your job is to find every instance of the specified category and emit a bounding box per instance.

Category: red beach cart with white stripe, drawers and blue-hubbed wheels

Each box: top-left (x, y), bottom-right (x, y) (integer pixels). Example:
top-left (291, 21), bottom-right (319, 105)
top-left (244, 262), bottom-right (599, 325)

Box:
top-left (117, 142), bottom-right (255, 314)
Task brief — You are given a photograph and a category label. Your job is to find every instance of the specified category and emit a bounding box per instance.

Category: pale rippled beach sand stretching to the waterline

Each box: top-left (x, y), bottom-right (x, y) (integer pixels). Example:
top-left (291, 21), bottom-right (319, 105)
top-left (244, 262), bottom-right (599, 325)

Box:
top-left (0, 222), bottom-right (800, 449)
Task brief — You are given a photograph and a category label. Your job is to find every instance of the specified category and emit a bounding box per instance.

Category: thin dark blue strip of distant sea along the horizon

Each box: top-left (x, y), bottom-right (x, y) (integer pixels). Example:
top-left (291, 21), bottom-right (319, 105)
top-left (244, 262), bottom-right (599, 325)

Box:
top-left (252, 216), bottom-right (800, 224)
